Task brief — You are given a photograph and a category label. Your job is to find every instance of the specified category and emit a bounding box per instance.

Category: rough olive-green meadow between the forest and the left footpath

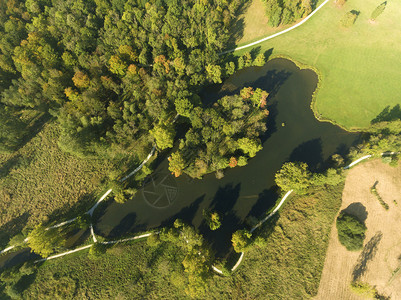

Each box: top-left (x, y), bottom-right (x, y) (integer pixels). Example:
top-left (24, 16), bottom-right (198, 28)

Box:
top-left (0, 122), bottom-right (113, 245)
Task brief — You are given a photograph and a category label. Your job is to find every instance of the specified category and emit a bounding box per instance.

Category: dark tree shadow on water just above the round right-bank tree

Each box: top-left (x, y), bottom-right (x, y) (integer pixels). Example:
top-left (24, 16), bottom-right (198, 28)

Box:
top-left (289, 138), bottom-right (324, 172)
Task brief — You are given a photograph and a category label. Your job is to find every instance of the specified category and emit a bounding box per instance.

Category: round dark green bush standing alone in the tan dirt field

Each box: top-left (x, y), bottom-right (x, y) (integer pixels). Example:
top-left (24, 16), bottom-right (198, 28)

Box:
top-left (336, 212), bottom-right (366, 251)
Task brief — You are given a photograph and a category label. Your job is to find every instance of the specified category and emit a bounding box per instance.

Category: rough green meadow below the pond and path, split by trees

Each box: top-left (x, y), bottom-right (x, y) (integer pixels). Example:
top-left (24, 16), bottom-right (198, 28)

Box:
top-left (14, 186), bottom-right (343, 299)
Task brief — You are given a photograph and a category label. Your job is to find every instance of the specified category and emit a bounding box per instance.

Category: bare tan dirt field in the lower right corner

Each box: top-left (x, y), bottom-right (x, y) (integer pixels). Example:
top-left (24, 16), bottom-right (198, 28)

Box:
top-left (316, 160), bottom-right (401, 300)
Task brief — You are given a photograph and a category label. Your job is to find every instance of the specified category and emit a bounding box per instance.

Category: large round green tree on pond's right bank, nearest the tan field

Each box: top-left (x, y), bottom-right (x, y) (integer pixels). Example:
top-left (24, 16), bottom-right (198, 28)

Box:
top-left (276, 162), bottom-right (312, 194)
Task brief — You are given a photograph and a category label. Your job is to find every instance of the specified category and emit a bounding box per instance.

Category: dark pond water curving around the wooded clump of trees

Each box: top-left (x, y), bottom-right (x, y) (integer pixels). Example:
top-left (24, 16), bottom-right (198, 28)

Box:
top-left (95, 59), bottom-right (359, 255)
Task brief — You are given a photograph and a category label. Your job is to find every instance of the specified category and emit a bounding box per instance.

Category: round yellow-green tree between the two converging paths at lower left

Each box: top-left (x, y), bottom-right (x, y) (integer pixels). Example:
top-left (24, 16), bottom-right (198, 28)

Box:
top-left (27, 224), bottom-right (66, 257)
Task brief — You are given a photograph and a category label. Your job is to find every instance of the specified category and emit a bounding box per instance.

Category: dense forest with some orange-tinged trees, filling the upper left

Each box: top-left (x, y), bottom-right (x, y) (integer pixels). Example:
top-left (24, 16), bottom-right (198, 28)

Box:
top-left (0, 0), bottom-right (248, 169)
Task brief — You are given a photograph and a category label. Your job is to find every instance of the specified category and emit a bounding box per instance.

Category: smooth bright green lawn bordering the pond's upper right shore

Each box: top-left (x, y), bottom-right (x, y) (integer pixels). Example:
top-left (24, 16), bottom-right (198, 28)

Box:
top-left (235, 0), bottom-right (401, 129)
